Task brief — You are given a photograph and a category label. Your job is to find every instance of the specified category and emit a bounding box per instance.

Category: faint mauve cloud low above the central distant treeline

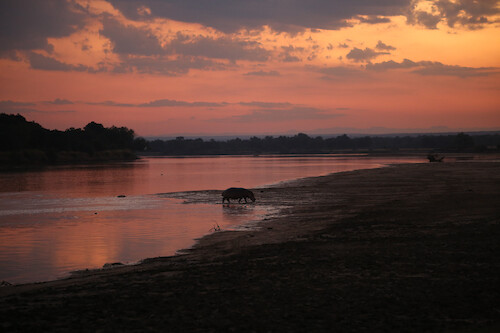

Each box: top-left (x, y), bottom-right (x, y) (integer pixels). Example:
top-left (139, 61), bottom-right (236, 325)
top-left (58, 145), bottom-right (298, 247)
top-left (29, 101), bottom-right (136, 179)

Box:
top-left (223, 106), bottom-right (343, 123)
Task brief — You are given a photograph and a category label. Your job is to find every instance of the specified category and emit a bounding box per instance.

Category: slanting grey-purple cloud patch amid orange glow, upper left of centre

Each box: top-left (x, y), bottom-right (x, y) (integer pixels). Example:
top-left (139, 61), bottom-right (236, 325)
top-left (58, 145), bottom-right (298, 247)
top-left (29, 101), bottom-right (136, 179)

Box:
top-left (99, 17), bottom-right (165, 56)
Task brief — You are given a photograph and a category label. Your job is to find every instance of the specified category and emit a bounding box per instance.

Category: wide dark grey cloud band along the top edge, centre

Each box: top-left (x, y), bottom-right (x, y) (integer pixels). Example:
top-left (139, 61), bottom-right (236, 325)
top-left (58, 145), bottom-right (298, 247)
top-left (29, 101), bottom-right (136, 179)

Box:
top-left (108, 0), bottom-right (411, 33)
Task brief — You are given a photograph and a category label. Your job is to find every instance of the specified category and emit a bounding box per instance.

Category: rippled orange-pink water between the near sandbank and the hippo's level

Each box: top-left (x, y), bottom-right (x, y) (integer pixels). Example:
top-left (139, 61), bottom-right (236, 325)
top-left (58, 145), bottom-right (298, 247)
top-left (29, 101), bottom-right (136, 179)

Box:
top-left (0, 195), bottom-right (272, 283)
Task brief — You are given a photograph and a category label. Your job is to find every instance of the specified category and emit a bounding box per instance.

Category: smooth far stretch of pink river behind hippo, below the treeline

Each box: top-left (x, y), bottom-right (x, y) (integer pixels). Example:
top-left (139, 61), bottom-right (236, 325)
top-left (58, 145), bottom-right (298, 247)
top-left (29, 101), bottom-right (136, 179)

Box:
top-left (0, 155), bottom-right (422, 197)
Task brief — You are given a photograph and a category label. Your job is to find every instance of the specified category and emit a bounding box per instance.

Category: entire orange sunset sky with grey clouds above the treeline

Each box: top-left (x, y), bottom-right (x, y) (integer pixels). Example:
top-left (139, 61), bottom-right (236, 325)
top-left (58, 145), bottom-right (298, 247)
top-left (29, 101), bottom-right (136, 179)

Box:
top-left (0, 0), bottom-right (500, 137)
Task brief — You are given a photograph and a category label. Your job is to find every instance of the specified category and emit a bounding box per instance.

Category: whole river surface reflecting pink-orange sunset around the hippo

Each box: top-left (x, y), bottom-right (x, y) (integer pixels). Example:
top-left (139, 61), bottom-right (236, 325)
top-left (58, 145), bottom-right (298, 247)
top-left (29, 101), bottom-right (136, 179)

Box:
top-left (0, 155), bottom-right (424, 283)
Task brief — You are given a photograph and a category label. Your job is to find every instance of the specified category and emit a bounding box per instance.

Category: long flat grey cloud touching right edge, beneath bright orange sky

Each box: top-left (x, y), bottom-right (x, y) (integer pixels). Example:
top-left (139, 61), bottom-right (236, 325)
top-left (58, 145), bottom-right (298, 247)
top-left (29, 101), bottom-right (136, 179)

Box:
top-left (366, 59), bottom-right (500, 78)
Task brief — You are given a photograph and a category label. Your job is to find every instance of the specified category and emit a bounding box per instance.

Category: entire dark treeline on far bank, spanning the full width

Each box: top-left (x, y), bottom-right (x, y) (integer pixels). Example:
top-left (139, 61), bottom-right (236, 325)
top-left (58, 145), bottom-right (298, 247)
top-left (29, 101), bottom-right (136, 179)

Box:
top-left (0, 113), bottom-right (500, 167)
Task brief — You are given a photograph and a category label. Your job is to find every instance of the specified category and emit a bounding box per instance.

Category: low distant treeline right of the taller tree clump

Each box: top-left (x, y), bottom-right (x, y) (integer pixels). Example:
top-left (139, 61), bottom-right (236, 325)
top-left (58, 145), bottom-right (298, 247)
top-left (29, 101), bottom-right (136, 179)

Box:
top-left (148, 133), bottom-right (500, 155)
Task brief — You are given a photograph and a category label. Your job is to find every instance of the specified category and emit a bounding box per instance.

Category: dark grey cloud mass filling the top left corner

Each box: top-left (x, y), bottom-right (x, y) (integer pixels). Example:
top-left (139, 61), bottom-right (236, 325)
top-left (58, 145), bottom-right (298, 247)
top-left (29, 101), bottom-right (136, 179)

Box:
top-left (0, 0), bottom-right (85, 56)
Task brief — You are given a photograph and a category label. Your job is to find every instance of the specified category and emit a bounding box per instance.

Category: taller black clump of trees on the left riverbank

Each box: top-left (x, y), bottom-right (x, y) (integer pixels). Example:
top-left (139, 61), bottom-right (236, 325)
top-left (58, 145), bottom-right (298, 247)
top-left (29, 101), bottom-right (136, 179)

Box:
top-left (0, 113), bottom-right (146, 164)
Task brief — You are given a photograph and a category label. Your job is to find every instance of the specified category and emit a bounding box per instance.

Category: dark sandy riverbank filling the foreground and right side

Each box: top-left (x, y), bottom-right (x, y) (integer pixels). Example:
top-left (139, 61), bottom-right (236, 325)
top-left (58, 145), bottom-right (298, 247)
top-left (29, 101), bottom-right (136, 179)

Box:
top-left (0, 162), bottom-right (500, 332)
